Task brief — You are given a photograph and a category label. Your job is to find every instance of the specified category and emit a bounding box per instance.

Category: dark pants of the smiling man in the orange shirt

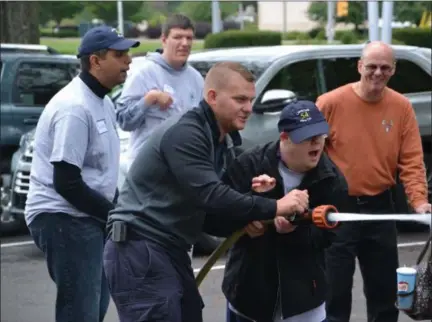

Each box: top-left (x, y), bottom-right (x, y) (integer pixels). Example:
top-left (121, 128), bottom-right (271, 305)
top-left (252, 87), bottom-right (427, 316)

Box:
top-left (326, 201), bottom-right (399, 322)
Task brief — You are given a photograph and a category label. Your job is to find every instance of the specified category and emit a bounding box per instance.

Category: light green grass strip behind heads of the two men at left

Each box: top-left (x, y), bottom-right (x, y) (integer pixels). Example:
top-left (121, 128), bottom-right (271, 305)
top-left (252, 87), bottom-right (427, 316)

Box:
top-left (40, 38), bottom-right (204, 55)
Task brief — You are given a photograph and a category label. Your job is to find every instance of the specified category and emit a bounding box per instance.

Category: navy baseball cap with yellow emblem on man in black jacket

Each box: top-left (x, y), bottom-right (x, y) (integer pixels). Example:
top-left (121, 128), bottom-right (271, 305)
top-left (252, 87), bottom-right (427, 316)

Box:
top-left (278, 101), bottom-right (329, 144)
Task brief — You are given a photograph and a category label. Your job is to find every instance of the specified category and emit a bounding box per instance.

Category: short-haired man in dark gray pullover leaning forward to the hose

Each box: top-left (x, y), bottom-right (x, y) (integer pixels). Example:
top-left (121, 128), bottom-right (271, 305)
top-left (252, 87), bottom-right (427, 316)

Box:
top-left (104, 62), bottom-right (308, 322)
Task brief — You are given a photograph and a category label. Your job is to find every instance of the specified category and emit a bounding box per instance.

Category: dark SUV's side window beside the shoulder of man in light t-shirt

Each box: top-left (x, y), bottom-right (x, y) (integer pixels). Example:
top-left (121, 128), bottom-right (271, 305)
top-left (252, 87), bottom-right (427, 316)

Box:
top-left (13, 62), bottom-right (77, 106)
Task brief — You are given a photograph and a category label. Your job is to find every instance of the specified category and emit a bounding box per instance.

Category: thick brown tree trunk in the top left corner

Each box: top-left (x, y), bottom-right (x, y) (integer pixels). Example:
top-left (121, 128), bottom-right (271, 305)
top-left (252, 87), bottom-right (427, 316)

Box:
top-left (0, 1), bottom-right (40, 44)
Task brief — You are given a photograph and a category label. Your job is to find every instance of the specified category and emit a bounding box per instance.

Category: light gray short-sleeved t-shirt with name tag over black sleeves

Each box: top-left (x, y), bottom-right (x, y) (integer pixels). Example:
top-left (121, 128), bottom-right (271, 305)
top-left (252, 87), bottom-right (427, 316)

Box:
top-left (25, 76), bottom-right (120, 225)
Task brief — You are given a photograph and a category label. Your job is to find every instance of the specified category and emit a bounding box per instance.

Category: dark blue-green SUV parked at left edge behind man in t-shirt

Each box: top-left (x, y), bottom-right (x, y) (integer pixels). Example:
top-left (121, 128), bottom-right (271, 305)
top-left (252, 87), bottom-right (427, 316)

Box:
top-left (0, 52), bottom-right (79, 232)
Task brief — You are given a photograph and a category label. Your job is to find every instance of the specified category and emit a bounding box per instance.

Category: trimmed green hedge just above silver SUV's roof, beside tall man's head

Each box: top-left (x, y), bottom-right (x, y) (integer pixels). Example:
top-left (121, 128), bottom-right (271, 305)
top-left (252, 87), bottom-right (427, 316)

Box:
top-left (204, 30), bottom-right (282, 48)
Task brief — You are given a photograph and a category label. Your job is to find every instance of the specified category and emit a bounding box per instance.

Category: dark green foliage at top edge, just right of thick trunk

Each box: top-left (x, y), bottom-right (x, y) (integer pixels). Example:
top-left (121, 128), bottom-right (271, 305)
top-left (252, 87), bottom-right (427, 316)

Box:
top-left (39, 1), bottom-right (84, 26)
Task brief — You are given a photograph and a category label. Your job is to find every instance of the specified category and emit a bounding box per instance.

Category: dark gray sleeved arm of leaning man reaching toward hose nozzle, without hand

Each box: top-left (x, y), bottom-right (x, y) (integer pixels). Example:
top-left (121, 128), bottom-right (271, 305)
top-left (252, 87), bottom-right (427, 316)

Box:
top-left (160, 123), bottom-right (277, 220)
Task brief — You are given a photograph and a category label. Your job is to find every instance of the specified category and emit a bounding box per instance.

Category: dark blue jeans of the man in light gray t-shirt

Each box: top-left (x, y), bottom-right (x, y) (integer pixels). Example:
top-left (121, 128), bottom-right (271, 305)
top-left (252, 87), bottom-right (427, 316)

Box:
top-left (29, 213), bottom-right (110, 322)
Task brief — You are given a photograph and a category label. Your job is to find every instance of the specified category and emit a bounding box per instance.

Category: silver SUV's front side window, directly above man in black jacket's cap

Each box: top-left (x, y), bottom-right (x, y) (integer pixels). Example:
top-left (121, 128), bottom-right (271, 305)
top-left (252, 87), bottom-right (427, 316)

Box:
top-left (263, 59), bottom-right (320, 101)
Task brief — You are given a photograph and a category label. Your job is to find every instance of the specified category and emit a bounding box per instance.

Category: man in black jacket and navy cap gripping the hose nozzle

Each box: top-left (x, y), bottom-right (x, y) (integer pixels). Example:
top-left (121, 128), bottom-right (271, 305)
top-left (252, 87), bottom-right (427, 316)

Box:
top-left (205, 101), bottom-right (351, 322)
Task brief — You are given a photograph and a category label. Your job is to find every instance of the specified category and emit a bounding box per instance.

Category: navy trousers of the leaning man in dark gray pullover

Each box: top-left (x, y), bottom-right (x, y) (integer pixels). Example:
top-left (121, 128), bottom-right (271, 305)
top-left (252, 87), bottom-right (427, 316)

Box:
top-left (104, 240), bottom-right (203, 322)
